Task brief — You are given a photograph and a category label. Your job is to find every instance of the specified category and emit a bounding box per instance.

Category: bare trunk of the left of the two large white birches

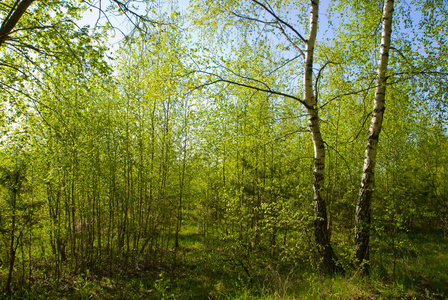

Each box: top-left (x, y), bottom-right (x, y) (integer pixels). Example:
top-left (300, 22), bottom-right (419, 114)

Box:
top-left (303, 0), bottom-right (337, 273)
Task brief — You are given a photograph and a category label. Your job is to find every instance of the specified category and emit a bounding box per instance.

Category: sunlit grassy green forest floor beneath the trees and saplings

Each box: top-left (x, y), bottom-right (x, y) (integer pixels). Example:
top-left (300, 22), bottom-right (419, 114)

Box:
top-left (0, 231), bottom-right (448, 299)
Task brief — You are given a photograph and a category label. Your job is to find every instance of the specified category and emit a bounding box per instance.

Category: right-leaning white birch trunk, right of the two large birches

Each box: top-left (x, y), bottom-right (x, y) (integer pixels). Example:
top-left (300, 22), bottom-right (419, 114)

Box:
top-left (355, 0), bottom-right (394, 273)
